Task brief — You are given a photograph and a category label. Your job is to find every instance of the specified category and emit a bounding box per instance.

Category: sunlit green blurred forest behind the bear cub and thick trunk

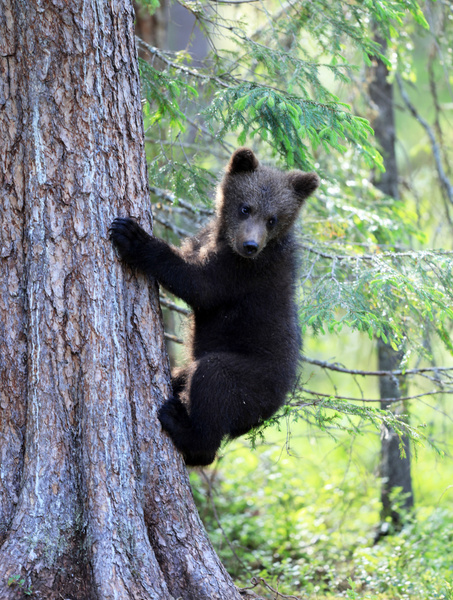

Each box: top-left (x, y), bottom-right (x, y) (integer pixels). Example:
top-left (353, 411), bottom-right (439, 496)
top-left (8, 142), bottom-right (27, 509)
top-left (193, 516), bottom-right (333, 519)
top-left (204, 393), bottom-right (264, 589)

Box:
top-left (132, 0), bottom-right (453, 600)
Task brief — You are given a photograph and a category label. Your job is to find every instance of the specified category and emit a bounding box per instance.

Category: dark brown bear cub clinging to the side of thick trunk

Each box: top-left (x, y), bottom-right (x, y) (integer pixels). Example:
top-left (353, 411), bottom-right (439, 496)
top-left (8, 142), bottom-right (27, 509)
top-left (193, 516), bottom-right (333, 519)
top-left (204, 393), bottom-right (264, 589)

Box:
top-left (110, 148), bottom-right (319, 465)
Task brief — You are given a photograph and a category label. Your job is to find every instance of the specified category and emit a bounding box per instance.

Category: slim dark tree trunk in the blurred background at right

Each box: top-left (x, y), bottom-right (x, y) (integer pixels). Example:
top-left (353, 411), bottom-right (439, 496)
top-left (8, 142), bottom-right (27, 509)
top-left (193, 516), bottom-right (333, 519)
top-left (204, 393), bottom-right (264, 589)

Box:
top-left (369, 38), bottom-right (414, 528)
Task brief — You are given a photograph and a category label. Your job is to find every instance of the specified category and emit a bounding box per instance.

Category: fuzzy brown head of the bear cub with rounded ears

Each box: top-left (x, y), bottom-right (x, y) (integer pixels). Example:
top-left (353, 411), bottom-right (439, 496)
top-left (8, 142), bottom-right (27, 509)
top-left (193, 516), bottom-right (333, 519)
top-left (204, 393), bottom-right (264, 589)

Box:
top-left (217, 148), bottom-right (319, 258)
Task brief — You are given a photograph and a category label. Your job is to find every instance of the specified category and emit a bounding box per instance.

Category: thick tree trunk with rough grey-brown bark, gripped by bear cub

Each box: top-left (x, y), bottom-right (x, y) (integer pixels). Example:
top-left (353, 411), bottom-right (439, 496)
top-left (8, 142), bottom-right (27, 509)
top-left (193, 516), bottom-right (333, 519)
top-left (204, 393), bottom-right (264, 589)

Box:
top-left (0, 0), bottom-right (239, 600)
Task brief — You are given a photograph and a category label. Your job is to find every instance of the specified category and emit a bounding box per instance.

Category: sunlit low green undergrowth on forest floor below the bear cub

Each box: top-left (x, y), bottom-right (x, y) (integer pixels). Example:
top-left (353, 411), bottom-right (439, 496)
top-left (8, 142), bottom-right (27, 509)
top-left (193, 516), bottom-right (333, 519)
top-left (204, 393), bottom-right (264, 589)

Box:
top-left (191, 432), bottom-right (453, 600)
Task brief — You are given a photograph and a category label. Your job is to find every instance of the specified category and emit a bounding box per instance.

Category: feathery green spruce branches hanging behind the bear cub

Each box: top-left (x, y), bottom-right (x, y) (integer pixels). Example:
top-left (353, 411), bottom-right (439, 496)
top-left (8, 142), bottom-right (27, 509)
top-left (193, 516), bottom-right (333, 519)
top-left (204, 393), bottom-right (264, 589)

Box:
top-left (135, 0), bottom-right (453, 450)
